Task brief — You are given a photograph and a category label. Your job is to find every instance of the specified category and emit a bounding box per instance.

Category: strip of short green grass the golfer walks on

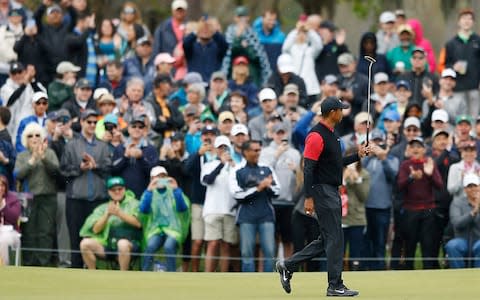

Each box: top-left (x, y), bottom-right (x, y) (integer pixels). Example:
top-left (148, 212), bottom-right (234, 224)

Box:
top-left (0, 267), bottom-right (480, 300)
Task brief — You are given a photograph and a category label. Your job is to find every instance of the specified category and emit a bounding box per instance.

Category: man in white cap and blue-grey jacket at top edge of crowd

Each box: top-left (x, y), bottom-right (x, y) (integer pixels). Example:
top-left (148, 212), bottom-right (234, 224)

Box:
top-left (153, 0), bottom-right (188, 56)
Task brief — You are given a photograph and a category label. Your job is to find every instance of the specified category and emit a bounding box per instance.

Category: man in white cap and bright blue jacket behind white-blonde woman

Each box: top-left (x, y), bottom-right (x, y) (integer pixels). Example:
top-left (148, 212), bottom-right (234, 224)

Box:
top-left (15, 92), bottom-right (48, 153)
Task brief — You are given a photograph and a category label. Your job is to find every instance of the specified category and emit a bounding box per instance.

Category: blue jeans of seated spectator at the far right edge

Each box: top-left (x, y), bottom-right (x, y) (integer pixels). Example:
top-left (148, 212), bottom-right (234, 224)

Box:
top-left (445, 238), bottom-right (480, 269)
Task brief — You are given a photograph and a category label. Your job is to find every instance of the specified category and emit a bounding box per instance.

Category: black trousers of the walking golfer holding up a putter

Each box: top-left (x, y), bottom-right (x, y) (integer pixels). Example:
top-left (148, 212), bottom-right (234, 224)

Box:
top-left (285, 184), bottom-right (343, 288)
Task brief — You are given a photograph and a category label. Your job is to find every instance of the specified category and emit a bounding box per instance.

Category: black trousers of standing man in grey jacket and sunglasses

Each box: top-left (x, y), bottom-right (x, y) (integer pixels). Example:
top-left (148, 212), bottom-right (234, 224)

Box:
top-left (66, 198), bottom-right (105, 268)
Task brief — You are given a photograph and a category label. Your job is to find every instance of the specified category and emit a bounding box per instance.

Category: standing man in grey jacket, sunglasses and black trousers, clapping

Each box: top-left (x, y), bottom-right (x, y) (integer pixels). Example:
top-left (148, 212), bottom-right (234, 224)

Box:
top-left (60, 109), bottom-right (112, 268)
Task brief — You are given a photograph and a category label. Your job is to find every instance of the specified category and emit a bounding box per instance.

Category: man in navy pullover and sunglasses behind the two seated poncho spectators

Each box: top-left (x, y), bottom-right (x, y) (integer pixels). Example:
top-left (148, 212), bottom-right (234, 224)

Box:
top-left (112, 115), bottom-right (158, 199)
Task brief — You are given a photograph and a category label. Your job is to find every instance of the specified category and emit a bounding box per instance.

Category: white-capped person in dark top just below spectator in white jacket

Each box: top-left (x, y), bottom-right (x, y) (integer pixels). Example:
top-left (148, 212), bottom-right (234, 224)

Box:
top-left (268, 53), bottom-right (308, 107)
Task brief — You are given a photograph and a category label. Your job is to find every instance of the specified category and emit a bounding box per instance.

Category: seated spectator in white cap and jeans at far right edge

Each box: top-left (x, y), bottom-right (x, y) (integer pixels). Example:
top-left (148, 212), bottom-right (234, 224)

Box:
top-left (445, 173), bottom-right (480, 269)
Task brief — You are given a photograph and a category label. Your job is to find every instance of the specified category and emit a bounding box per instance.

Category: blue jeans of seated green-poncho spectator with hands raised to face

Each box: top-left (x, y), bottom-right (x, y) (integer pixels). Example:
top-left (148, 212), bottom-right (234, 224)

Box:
top-left (142, 233), bottom-right (177, 272)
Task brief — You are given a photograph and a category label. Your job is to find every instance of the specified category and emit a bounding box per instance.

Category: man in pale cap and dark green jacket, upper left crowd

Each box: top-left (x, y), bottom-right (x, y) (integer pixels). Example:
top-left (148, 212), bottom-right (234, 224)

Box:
top-left (48, 61), bottom-right (82, 111)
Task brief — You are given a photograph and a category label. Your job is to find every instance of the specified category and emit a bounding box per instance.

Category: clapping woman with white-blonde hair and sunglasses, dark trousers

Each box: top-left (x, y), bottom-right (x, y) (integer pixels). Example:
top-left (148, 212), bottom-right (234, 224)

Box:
top-left (14, 122), bottom-right (59, 266)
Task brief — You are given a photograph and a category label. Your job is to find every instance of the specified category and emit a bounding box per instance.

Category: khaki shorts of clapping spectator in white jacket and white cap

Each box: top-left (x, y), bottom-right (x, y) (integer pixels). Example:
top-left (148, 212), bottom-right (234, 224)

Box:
top-left (205, 215), bottom-right (238, 245)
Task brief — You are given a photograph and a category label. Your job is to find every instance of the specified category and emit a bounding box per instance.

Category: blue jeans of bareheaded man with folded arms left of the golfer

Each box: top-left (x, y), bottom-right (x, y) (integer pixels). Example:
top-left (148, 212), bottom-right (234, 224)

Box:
top-left (240, 222), bottom-right (275, 272)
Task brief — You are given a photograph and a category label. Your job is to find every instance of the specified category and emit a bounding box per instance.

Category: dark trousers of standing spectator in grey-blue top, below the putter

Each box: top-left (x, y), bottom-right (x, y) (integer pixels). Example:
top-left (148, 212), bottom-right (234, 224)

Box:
top-left (366, 208), bottom-right (391, 270)
